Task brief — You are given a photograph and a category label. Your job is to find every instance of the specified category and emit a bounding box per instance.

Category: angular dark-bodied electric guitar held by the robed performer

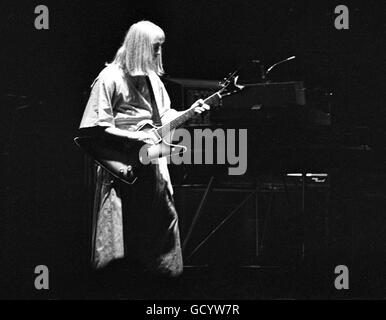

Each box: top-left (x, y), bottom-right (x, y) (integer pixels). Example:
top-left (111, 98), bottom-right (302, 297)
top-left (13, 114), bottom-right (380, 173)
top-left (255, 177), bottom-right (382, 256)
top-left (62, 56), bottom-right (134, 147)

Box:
top-left (74, 71), bottom-right (244, 184)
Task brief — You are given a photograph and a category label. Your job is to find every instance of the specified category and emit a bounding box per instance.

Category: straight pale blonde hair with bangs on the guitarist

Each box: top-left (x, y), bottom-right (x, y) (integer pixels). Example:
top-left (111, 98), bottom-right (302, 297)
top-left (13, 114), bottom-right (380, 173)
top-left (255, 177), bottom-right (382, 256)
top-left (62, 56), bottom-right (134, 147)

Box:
top-left (111, 20), bottom-right (165, 76)
